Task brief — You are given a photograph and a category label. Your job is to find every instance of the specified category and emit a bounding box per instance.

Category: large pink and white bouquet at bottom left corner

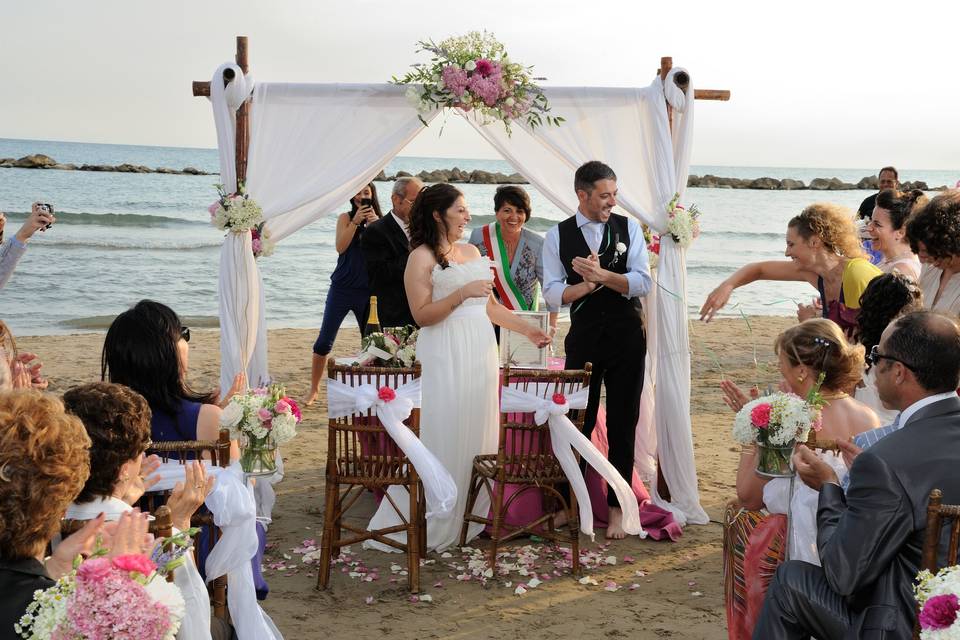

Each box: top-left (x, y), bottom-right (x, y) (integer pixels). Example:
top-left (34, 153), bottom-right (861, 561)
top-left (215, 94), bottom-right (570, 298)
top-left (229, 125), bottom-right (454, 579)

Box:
top-left (14, 550), bottom-right (185, 640)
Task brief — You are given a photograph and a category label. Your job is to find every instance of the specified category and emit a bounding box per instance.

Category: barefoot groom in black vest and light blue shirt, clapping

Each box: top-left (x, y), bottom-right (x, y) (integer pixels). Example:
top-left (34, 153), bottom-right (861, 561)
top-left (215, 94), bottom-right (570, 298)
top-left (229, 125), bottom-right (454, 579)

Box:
top-left (543, 160), bottom-right (653, 538)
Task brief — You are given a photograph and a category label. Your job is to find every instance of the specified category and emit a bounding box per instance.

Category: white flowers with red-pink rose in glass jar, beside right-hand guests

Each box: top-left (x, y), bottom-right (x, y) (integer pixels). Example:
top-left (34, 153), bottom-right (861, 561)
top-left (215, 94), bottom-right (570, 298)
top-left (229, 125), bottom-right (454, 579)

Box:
top-left (733, 373), bottom-right (824, 477)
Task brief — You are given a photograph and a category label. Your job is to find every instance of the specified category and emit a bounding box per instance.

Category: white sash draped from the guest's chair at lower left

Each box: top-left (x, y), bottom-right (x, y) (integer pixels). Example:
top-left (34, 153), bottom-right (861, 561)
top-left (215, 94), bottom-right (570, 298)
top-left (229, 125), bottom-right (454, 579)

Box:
top-left (150, 461), bottom-right (283, 640)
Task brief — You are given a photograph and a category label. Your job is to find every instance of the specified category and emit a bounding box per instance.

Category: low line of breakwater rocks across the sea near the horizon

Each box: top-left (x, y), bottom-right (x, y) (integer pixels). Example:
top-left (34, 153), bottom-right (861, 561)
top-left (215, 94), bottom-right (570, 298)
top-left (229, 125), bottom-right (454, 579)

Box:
top-left (0, 153), bottom-right (948, 191)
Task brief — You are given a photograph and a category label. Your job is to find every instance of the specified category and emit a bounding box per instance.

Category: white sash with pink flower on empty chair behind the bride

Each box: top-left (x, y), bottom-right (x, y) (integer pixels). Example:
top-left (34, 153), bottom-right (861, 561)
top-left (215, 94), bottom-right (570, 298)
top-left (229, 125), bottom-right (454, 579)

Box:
top-left (327, 378), bottom-right (457, 518)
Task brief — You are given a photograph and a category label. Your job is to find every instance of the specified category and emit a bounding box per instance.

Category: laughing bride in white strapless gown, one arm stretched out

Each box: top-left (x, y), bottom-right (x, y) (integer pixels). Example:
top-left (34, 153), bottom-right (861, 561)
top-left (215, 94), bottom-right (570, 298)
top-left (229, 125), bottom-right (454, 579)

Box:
top-left (367, 184), bottom-right (550, 551)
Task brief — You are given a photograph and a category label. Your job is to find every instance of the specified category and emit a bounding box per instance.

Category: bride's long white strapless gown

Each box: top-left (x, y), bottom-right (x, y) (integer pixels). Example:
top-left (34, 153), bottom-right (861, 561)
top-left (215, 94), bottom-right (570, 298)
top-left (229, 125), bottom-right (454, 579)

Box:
top-left (364, 258), bottom-right (500, 551)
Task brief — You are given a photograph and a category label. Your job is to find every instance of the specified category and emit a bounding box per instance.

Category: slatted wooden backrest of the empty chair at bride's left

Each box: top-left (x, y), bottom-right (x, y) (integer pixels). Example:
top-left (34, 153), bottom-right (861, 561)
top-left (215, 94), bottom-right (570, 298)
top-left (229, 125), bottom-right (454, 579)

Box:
top-left (327, 361), bottom-right (420, 486)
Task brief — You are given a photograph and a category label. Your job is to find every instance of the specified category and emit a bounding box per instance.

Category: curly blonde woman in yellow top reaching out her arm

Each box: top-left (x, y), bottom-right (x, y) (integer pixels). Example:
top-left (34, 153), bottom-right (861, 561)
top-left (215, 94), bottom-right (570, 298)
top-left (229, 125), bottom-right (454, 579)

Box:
top-left (700, 203), bottom-right (882, 336)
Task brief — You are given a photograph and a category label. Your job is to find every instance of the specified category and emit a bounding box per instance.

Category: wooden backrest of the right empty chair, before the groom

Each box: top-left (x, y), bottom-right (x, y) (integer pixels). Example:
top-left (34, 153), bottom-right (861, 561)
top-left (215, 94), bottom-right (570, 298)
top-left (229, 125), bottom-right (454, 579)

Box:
top-left (497, 362), bottom-right (593, 478)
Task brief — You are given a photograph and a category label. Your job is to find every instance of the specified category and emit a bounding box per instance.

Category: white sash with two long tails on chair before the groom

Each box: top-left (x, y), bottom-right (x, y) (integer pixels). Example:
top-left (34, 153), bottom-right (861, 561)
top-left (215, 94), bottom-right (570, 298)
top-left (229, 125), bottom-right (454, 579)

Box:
top-left (500, 383), bottom-right (647, 540)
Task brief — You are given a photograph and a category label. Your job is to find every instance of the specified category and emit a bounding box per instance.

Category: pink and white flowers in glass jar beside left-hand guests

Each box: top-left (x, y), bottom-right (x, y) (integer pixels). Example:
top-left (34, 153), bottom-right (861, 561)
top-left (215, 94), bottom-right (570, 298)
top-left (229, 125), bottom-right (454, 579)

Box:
top-left (220, 384), bottom-right (302, 475)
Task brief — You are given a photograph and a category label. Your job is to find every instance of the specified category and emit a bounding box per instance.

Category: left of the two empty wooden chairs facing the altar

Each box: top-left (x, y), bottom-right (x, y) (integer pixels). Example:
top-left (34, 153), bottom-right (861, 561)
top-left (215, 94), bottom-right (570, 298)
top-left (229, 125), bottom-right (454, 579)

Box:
top-left (317, 362), bottom-right (426, 593)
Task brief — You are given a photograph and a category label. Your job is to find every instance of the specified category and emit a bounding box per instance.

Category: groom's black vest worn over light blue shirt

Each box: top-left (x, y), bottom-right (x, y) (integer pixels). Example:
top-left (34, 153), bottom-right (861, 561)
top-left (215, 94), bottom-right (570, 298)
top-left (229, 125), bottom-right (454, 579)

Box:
top-left (558, 214), bottom-right (643, 333)
